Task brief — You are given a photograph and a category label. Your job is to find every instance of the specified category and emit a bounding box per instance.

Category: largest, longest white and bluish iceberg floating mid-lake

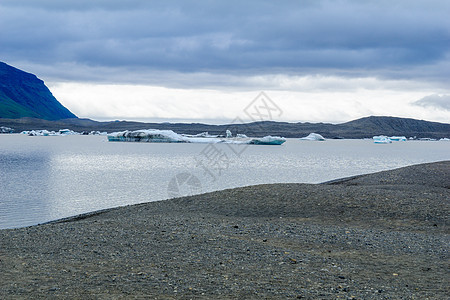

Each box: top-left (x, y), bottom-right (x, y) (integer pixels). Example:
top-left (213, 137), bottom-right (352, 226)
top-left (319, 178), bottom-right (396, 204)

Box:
top-left (108, 129), bottom-right (286, 145)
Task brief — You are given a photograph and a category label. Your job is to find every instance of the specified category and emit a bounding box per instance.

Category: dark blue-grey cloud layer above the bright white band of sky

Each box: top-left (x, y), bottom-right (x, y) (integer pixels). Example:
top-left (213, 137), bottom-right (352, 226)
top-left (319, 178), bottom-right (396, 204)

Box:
top-left (0, 0), bottom-right (450, 82)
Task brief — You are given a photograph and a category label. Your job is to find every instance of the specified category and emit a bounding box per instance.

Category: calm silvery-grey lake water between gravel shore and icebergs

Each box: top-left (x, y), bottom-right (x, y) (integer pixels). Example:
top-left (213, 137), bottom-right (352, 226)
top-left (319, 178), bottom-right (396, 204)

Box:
top-left (0, 135), bottom-right (450, 228)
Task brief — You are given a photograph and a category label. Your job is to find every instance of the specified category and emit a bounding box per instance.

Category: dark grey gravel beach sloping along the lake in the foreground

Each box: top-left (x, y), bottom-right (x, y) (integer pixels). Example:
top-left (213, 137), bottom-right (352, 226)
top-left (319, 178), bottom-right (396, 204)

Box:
top-left (0, 161), bottom-right (450, 299)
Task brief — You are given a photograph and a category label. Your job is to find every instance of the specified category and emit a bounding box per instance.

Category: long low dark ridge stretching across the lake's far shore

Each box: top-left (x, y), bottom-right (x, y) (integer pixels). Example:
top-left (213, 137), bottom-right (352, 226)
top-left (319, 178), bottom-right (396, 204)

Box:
top-left (0, 116), bottom-right (450, 139)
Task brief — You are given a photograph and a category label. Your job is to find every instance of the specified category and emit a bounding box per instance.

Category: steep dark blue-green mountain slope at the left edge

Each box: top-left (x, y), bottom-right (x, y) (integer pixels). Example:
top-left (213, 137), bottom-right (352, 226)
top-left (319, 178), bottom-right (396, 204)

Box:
top-left (0, 62), bottom-right (77, 120)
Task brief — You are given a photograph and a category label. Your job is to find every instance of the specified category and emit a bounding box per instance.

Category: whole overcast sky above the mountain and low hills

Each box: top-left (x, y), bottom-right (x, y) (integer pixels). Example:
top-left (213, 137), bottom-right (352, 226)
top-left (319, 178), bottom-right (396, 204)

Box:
top-left (0, 0), bottom-right (450, 124)
